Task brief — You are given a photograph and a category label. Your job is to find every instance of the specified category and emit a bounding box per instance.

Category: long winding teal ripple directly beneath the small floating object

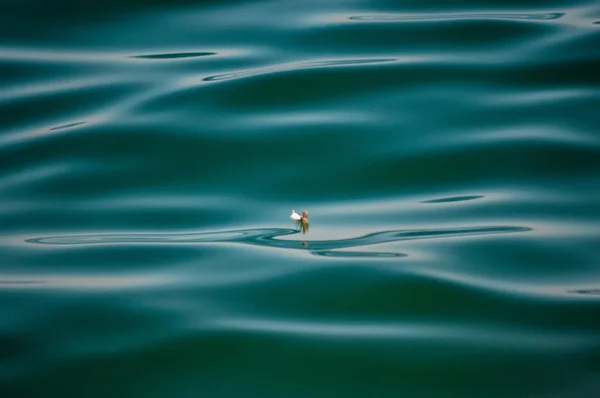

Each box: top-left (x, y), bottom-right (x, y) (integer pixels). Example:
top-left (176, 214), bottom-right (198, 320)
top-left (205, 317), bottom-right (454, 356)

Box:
top-left (26, 226), bottom-right (531, 258)
